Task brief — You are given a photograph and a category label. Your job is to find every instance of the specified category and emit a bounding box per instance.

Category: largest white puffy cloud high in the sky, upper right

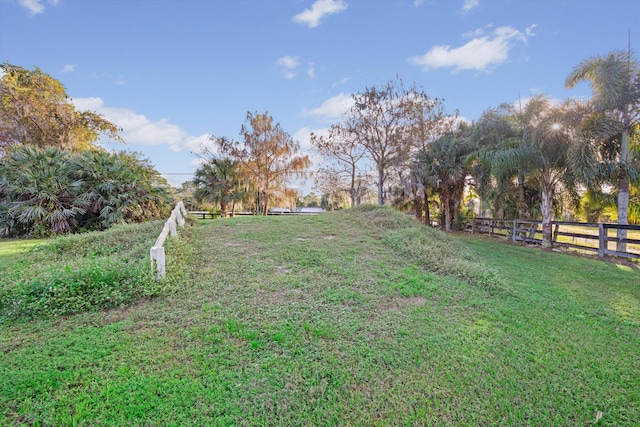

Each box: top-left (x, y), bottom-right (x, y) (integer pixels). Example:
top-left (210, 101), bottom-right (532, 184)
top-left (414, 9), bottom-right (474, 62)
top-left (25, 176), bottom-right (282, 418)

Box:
top-left (409, 25), bottom-right (535, 71)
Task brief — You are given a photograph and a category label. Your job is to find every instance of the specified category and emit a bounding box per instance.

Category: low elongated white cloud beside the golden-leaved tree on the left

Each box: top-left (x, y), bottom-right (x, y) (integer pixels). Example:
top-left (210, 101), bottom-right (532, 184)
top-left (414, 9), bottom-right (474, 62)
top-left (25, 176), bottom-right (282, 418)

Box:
top-left (73, 98), bottom-right (208, 151)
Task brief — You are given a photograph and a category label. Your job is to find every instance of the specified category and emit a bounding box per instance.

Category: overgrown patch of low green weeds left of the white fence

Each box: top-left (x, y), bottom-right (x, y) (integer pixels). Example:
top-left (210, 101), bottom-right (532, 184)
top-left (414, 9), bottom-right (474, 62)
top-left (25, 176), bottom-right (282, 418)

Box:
top-left (0, 221), bottom-right (170, 320)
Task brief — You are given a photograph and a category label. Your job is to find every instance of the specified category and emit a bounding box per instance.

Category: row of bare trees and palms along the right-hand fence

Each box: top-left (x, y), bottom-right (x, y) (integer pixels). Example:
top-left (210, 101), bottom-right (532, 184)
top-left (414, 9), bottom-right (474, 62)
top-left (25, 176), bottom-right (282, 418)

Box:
top-left (311, 51), bottom-right (640, 250)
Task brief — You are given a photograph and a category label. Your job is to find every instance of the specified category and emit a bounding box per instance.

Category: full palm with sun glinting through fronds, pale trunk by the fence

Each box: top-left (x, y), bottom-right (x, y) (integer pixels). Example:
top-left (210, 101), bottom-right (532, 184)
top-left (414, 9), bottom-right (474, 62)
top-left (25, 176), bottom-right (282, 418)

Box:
top-left (474, 95), bottom-right (590, 248)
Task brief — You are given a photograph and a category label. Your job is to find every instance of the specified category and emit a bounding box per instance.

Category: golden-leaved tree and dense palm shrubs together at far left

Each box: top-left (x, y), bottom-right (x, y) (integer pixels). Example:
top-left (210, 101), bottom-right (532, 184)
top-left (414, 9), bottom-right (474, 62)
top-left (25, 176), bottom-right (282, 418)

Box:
top-left (0, 63), bottom-right (172, 236)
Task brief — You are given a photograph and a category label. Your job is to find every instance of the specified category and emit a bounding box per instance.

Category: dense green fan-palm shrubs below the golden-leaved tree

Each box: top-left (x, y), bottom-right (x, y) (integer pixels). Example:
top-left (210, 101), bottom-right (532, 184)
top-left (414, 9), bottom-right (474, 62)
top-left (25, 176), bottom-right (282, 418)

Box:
top-left (0, 145), bottom-right (171, 236)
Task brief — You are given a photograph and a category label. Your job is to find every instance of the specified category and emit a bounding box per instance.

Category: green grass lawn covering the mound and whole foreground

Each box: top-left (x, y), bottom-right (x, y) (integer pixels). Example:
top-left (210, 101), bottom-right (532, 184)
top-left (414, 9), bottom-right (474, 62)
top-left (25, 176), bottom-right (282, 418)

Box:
top-left (0, 209), bottom-right (640, 426)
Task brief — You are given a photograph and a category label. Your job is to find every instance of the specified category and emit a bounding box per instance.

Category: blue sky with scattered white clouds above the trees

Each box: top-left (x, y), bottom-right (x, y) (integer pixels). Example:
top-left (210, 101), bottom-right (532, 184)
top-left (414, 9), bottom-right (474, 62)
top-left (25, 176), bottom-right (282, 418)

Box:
top-left (0, 0), bottom-right (640, 192)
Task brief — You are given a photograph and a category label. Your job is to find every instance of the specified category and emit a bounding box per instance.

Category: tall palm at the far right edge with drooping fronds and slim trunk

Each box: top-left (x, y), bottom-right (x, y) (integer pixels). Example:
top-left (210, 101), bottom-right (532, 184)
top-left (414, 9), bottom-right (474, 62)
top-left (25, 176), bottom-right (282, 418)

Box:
top-left (565, 50), bottom-right (640, 251)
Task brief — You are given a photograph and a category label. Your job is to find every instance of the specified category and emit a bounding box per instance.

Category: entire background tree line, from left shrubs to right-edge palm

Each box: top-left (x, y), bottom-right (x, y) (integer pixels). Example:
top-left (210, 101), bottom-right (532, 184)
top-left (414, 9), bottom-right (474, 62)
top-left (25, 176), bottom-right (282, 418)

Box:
top-left (0, 45), bottom-right (640, 250)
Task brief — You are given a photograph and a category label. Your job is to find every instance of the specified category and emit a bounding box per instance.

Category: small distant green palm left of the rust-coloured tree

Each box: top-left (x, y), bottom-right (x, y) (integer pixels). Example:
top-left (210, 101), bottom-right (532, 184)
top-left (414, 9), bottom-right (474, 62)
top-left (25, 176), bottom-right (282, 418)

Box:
top-left (193, 158), bottom-right (244, 217)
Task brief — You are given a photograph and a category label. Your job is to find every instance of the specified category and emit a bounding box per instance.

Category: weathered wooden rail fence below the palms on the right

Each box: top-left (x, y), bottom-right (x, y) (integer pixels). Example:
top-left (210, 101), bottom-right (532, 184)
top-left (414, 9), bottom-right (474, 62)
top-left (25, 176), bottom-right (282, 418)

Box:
top-left (468, 218), bottom-right (640, 258)
